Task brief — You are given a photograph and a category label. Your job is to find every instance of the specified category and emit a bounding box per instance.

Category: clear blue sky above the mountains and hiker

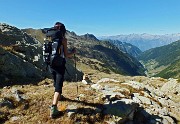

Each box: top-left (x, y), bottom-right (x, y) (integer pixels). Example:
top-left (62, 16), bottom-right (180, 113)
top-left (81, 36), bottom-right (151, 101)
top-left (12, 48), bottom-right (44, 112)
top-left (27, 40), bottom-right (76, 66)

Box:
top-left (0, 0), bottom-right (180, 36)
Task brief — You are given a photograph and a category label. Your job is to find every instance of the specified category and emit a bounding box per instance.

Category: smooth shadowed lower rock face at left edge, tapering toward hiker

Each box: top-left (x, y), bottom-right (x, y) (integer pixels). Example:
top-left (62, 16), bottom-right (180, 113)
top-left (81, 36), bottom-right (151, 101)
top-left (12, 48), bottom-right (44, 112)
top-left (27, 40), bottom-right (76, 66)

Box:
top-left (0, 47), bottom-right (43, 85)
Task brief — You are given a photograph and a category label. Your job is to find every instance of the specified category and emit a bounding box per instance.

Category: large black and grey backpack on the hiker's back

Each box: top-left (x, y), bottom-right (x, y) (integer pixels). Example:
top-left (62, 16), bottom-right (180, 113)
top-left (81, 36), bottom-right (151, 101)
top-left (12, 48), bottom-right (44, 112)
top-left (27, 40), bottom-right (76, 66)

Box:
top-left (43, 28), bottom-right (65, 70)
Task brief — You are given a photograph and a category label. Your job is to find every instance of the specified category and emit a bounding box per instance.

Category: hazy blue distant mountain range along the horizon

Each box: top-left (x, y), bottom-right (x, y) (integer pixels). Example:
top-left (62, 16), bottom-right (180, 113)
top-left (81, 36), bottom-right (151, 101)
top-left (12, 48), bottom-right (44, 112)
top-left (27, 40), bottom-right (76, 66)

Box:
top-left (98, 33), bottom-right (180, 51)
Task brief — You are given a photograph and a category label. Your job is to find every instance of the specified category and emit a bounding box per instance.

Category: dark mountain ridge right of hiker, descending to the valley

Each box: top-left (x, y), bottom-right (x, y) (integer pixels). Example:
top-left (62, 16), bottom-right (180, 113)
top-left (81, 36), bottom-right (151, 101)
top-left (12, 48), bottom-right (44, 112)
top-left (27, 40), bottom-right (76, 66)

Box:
top-left (67, 32), bottom-right (144, 75)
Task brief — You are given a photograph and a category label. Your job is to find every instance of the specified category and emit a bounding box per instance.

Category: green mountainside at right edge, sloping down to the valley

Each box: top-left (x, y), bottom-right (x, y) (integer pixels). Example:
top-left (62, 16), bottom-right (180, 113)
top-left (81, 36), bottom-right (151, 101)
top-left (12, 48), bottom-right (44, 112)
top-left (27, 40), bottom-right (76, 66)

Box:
top-left (138, 40), bottom-right (180, 78)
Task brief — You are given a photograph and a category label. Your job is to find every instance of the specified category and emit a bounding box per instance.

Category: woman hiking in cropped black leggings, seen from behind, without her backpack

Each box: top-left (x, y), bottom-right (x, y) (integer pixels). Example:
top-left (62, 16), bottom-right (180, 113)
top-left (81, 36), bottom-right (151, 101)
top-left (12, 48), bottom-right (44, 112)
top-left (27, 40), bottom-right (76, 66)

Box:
top-left (50, 22), bottom-right (76, 118)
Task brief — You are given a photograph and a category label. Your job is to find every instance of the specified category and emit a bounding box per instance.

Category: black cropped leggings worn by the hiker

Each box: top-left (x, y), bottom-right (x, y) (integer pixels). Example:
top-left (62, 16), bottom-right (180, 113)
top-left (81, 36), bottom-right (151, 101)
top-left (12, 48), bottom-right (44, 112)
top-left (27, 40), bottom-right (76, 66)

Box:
top-left (51, 66), bottom-right (65, 94)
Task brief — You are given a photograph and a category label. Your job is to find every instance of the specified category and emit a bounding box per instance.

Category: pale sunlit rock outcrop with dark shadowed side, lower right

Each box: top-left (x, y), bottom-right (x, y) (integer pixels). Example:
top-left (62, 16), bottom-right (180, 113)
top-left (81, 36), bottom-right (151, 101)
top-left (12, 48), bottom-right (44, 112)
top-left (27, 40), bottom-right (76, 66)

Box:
top-left (91, 78), bottom-right (180, 124)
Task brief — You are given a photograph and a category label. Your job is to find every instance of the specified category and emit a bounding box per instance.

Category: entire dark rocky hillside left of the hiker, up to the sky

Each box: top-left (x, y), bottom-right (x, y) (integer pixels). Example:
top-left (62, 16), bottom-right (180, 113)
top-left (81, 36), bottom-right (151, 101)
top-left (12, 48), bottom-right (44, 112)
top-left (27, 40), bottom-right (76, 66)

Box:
top-left (0, 24), bottom-right (44, 85)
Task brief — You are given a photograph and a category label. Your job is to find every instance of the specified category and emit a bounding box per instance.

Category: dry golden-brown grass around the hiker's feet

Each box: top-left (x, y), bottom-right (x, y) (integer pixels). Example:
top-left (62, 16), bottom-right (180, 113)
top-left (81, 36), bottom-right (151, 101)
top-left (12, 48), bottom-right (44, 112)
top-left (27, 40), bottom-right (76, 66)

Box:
top-left (0, 81), bottom-right (108, 124)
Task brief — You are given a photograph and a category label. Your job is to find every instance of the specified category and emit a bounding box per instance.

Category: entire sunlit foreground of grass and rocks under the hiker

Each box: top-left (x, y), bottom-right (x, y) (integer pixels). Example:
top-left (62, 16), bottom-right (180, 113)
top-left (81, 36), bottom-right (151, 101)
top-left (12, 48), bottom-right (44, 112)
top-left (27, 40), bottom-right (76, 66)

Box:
top-left (0, 75), bottom-right (180, 124)
